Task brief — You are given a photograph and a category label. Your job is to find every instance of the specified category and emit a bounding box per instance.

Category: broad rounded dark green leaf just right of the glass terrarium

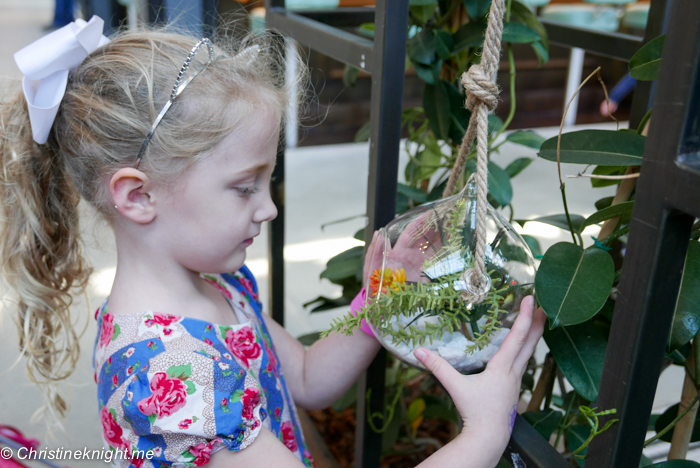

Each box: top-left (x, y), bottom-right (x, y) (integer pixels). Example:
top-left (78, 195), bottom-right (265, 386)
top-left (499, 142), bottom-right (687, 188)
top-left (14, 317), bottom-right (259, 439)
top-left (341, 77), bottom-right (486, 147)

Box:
top-left (535, 242), bottom-right (615, 327)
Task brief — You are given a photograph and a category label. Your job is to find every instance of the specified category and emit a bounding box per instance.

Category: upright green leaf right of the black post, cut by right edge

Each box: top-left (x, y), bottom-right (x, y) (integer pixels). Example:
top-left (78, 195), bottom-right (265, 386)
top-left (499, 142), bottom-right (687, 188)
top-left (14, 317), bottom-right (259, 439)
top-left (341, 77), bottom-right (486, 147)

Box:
top-left (669, 242), bottom-right (700, 351)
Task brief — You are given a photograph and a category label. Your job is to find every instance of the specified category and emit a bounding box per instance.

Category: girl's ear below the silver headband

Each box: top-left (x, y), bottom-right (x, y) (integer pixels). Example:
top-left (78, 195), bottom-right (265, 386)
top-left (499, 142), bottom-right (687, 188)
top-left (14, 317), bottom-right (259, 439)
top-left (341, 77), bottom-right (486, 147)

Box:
top-left (109, 167), bottom-right (156, 224)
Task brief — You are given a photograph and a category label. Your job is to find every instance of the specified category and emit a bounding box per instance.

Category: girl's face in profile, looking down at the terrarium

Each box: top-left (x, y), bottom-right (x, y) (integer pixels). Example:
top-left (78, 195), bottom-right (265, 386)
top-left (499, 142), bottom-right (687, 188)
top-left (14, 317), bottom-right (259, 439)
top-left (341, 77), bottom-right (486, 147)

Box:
top-left (154, 105), bottom-right (279, 273)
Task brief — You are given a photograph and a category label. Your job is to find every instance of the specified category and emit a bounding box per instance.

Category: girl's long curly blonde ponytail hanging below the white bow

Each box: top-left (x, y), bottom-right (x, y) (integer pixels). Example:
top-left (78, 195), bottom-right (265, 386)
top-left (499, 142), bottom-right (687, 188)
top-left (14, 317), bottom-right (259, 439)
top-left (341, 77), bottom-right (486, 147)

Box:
top-left (0, 87), bottom-right (90, 416)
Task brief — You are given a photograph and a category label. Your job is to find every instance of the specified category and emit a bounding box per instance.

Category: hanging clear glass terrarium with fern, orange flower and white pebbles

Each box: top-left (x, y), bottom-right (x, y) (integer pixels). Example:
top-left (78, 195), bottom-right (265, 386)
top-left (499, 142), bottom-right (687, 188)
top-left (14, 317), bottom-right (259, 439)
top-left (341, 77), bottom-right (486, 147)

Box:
top-left (358, 177), bottom-right (535, 373)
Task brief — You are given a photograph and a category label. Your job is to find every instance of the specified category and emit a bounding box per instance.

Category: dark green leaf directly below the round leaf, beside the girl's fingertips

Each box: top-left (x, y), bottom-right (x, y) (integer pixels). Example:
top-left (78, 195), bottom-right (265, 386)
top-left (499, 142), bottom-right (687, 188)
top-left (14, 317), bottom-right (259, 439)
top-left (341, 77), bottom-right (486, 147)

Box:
top-left (538, 322), bottom-right (608, 401)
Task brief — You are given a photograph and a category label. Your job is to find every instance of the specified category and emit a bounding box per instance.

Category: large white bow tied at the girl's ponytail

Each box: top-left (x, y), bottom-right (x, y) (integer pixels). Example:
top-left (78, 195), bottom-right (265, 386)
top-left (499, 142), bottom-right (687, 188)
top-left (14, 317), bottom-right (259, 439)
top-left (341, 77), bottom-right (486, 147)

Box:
top-left (15, 16), bottom-right (109, 144)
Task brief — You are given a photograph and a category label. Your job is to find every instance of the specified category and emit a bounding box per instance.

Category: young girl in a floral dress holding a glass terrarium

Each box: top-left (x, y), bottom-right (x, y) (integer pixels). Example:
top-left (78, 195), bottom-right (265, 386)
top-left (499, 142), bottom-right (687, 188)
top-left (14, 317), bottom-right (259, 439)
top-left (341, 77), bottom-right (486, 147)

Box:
top-left (0, 18), bottom-right (544, 467)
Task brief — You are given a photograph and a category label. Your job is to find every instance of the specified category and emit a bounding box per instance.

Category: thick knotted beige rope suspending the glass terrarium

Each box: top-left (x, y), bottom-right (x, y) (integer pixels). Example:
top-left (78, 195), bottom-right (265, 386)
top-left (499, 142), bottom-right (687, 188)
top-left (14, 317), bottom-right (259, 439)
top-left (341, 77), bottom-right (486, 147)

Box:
top-left (442, 0), bottom-right (506, 302)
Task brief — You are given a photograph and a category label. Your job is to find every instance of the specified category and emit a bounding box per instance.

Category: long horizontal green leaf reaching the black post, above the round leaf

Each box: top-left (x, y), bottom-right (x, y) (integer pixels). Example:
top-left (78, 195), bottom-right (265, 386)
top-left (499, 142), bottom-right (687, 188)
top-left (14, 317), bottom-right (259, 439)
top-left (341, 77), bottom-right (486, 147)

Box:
top-left (538, 130), bottom-right (646, 166)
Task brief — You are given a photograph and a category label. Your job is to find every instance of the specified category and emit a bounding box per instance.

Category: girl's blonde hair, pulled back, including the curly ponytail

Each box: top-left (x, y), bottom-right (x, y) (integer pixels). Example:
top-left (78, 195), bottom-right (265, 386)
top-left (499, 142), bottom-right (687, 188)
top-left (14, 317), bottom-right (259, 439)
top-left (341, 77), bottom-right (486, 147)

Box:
top-left (0, 26), bottom-right (296, 416)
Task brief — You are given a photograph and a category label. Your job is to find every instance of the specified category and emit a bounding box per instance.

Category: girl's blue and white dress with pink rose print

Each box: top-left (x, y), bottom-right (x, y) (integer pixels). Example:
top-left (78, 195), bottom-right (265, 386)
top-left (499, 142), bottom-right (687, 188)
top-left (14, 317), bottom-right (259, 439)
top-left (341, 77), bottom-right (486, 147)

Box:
top-left (94, 266), bottom-right (314, 468)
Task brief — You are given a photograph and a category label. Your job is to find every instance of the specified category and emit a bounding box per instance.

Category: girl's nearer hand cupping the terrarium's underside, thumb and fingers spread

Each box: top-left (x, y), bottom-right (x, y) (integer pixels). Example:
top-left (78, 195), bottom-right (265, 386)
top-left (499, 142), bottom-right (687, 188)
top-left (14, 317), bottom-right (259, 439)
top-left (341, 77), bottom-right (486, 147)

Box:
top-left (414, 296), bottom-right (546, 450)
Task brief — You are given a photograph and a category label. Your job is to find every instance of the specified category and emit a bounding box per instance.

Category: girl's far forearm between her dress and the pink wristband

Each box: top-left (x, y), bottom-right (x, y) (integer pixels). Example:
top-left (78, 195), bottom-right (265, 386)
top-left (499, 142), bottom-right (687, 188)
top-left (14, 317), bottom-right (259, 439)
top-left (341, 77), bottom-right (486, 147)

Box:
top-left (265, 317), bottom-right (381, 410)
